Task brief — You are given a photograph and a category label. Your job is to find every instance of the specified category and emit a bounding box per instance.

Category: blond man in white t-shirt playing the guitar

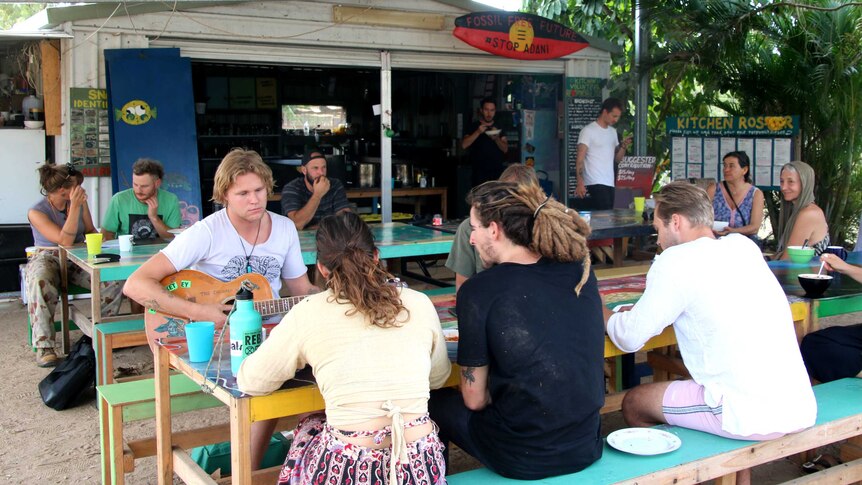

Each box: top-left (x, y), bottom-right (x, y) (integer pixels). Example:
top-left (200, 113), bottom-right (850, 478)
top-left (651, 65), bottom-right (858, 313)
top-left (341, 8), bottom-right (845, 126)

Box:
top-left (123, 149), bottom-right (320, 467)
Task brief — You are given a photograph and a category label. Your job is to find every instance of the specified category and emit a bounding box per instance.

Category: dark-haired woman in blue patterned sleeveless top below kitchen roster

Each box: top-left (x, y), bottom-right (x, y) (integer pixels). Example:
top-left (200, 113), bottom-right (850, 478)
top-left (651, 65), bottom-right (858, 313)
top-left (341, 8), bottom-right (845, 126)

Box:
top-left (707, 151), bottom-right (763, 241)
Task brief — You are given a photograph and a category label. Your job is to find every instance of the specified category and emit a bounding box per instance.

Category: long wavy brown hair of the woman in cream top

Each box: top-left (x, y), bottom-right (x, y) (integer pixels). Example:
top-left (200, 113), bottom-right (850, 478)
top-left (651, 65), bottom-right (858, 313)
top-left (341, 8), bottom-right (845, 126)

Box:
top-left (316, 212), bottom-right (410, 328)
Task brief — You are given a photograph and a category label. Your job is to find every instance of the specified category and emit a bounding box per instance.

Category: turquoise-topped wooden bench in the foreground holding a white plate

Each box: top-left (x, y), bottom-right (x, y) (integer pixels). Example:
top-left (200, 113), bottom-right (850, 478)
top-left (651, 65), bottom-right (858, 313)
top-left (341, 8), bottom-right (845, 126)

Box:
top-left (447, 378), bottom-right (862, 485)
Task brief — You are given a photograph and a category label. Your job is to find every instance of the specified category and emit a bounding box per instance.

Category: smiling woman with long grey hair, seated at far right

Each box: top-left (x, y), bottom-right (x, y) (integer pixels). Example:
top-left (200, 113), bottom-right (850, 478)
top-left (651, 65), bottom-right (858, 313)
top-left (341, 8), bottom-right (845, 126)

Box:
top-left (772, 161), bottom-right (829, 259)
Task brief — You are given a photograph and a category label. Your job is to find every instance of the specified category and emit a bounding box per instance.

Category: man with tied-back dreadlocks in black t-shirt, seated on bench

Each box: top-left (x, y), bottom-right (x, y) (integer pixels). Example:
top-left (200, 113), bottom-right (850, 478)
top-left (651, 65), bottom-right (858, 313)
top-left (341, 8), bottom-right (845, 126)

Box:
top-left (430, 181), bottom-right (604, 480)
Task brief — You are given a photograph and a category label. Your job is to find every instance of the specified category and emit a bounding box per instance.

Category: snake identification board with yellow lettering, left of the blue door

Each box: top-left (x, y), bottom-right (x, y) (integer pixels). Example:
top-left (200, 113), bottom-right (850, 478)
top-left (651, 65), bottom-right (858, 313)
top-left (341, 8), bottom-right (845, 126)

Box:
top-left (69, 88), bottom-right (111, 176)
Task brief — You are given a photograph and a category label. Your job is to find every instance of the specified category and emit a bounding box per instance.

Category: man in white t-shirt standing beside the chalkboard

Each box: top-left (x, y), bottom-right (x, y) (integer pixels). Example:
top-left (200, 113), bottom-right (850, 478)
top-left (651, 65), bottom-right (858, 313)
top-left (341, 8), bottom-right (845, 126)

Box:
top-left (575, 98), bottom-right (632, 210)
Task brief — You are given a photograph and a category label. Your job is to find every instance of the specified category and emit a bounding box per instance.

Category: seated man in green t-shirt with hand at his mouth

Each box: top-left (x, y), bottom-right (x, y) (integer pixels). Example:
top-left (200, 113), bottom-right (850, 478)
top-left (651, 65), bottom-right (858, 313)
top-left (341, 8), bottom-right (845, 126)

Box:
top-left (102, 158), bottom-right (182, 241)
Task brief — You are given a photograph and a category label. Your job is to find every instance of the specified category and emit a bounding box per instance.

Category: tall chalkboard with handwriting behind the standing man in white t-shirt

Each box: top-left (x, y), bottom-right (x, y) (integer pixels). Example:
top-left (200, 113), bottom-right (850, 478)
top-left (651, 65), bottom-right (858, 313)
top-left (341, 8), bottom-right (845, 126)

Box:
top-left (565, 77), bottom-right (607, 205)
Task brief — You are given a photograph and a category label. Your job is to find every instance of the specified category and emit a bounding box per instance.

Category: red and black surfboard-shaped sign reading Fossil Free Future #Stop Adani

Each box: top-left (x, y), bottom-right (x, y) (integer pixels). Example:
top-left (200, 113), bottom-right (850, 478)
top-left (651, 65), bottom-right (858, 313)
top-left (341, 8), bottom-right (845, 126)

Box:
top-left (452, 12), bottom-right (590, 61)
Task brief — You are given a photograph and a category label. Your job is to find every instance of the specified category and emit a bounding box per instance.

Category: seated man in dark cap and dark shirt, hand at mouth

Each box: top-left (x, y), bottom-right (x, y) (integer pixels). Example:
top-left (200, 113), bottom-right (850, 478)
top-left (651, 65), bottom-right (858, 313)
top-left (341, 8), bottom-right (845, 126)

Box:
top-left (281, 149), bottom-right (350, 230)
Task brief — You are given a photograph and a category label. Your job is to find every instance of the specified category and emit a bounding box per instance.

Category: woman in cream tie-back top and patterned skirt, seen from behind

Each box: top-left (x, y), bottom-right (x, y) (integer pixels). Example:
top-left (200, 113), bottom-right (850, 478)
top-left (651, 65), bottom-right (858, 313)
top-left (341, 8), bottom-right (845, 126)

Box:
top-left (237, 212), bottom-right (451, 485)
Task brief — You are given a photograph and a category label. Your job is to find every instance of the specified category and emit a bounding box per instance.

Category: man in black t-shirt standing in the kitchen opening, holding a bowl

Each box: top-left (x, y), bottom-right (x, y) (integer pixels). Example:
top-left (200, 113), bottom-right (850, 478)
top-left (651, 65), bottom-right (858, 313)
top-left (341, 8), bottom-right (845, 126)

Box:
top-left (461, 98), bottom-right (509, 187)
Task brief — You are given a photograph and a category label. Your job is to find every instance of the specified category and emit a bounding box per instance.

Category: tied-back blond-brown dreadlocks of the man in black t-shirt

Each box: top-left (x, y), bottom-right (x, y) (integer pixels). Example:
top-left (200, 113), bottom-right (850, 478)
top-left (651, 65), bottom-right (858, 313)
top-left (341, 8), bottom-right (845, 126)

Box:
top-left (467, 181), bottom-right (590, 295)
